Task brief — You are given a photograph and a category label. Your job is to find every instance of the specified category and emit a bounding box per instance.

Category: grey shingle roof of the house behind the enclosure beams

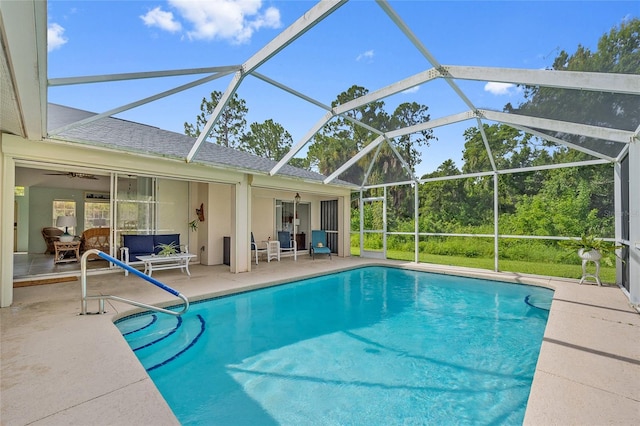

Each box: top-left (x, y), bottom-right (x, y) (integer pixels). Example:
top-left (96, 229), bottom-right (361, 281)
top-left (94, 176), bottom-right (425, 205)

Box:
top-left (47, 103), bottom-right (353, 186)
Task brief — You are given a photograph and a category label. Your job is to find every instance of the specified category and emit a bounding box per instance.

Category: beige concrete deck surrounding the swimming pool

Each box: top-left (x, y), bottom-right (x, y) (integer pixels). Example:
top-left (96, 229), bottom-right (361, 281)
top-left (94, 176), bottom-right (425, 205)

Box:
top-left (0, 256), bottom-right (640, 426)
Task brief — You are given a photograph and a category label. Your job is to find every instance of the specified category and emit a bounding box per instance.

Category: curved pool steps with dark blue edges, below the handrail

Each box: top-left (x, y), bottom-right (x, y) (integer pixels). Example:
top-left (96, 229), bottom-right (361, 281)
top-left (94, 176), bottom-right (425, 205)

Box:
top-left (117, 314), bottom-right (205, 371)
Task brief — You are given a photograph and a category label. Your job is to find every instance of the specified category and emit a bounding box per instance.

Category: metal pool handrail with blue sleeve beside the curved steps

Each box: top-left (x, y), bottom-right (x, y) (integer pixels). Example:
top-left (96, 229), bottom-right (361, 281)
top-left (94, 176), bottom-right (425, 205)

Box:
top-left (80, 249), bottom-right (189, 316)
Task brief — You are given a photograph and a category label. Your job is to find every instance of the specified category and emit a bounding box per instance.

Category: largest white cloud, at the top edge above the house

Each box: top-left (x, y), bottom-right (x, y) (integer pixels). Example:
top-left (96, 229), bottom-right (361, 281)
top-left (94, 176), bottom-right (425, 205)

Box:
top-left (169, 0), bottom-right (282, 43)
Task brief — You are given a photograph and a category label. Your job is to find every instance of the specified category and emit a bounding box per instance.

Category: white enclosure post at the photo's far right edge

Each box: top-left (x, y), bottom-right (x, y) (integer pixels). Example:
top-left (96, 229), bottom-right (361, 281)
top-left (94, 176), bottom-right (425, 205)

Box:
top-left (628, 139), bottom-right (640, 305)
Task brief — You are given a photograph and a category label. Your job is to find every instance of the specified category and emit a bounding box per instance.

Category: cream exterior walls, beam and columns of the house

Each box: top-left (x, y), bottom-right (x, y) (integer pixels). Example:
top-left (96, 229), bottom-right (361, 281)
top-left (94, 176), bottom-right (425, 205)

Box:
top-left (0, 134), bottom-right (350, 307)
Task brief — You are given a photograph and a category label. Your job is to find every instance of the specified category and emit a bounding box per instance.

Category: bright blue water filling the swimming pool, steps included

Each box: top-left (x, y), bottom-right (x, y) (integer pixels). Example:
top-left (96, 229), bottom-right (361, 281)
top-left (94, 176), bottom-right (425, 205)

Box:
top-left (116, 267), bottom-right (553, 425)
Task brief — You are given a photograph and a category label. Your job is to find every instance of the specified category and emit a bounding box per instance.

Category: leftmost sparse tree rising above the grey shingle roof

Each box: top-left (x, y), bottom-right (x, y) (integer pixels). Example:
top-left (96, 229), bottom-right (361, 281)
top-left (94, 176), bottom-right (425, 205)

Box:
top-left (184, 91), bottom-right (249, 148)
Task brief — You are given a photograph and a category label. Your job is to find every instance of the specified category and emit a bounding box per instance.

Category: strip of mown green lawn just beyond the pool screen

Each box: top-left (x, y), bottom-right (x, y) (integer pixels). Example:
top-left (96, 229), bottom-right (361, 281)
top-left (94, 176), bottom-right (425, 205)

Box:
top-left (351, 247), bottom-right (616, 284)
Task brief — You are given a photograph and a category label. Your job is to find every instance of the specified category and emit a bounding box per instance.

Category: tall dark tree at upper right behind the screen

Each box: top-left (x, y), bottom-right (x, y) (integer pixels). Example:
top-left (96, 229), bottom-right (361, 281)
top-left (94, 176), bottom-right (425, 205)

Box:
top-left (505, 18), bottom-right (640, 236)
